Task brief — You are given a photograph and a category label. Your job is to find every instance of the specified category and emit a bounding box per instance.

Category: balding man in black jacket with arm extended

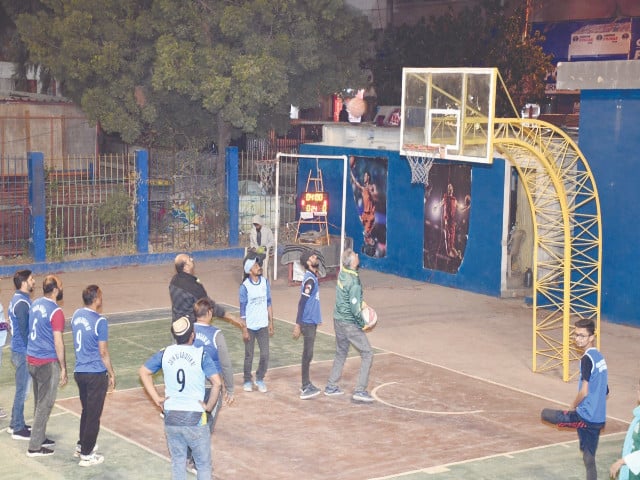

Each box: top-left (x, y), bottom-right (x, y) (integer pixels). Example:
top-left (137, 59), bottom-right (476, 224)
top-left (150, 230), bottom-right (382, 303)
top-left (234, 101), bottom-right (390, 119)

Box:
top-left (169, 253), bottom-right (226, 323)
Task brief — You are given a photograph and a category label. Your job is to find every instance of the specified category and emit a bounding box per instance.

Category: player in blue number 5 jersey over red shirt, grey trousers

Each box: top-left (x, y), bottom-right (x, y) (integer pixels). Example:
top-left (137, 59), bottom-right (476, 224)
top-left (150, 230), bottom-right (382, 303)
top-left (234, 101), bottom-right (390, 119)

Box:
top-left (27, 275), bottom-right (67, 457)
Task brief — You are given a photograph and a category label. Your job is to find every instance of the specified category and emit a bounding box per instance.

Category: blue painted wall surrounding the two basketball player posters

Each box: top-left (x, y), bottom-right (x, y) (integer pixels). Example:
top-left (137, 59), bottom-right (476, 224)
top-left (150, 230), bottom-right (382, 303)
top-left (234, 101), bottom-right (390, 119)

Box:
top-left (298, 144), bottom-right (504, 296)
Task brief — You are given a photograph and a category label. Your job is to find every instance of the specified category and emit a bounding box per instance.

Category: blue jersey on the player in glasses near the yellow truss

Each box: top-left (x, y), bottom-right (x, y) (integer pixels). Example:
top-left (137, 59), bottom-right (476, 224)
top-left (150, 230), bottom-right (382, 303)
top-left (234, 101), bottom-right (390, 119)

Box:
top-left (576, 348), bottom-right (609, 423)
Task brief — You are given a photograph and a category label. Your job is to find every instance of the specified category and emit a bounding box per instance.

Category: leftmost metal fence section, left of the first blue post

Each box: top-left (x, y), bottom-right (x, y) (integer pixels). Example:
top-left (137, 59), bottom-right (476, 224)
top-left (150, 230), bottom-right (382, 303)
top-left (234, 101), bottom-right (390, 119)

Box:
top-left (0, 157), bottom-right (31, 262)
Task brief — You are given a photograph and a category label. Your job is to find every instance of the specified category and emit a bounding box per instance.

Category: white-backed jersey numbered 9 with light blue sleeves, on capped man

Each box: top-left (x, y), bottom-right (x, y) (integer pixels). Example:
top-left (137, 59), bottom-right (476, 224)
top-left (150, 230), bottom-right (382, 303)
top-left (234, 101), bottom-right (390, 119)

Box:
top-left (144, 345), bottom-right (218, 412)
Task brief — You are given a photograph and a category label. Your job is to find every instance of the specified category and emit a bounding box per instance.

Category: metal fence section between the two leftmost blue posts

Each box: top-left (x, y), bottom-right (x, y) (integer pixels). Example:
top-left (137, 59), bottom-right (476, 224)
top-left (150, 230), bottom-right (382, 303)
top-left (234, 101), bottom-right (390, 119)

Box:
top-left (45, 155), bottom-right (136, 260)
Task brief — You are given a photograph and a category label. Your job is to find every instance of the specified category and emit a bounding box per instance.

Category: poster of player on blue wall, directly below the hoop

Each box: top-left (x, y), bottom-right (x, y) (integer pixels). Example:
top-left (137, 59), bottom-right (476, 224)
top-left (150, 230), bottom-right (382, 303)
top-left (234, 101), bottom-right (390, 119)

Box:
top-left (423, 164), bottom-right (471, 273)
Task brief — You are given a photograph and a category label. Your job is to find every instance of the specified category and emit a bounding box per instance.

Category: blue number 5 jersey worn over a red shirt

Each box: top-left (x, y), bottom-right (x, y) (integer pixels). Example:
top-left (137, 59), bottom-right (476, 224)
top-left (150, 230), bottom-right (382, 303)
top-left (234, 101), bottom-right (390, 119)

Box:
top-left (27, 297), bottom-right (64, 360)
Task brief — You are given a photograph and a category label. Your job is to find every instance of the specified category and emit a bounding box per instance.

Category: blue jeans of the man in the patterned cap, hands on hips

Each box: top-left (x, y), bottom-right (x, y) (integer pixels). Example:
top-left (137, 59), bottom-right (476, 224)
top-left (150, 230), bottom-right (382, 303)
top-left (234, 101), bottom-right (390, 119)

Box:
top-left (164, 425), bottom-right (211, 480)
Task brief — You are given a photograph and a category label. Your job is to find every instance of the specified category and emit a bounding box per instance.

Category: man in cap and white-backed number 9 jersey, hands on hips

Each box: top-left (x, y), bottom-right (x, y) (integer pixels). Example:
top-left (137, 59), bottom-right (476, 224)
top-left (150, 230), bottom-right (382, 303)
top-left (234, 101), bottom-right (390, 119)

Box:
top-left (139, 317), bottom-right (221, 480)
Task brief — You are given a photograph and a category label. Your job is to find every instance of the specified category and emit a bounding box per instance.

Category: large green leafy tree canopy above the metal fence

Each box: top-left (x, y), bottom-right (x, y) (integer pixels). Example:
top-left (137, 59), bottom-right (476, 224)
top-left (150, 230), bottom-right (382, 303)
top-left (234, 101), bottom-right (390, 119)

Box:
top-left (10, 0), bottom-right (370, 160)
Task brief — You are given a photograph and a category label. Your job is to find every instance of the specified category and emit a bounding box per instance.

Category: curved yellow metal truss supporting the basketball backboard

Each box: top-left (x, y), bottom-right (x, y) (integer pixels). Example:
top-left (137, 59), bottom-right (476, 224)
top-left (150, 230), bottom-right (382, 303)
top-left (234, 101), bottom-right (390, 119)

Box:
top-left (493, 118), bottom-right (602, 381)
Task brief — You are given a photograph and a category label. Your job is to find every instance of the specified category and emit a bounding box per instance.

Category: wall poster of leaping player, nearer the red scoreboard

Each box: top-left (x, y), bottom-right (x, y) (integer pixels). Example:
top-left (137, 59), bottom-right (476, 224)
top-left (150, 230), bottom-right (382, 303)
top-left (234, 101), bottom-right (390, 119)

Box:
top-left (349, 155), bottom-right (388, 258)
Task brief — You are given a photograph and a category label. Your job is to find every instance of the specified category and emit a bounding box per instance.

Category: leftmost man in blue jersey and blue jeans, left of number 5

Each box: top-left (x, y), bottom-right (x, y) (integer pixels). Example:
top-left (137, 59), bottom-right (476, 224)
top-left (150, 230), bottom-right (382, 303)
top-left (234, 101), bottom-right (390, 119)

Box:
top-left (8, 270), bottom-right (36, 440)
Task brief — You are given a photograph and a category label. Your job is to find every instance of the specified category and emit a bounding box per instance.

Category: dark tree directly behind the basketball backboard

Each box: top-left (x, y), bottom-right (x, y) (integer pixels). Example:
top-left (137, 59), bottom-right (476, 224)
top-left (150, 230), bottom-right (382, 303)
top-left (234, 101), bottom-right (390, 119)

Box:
top-left (371, 0), bottom-right (551, 116)
